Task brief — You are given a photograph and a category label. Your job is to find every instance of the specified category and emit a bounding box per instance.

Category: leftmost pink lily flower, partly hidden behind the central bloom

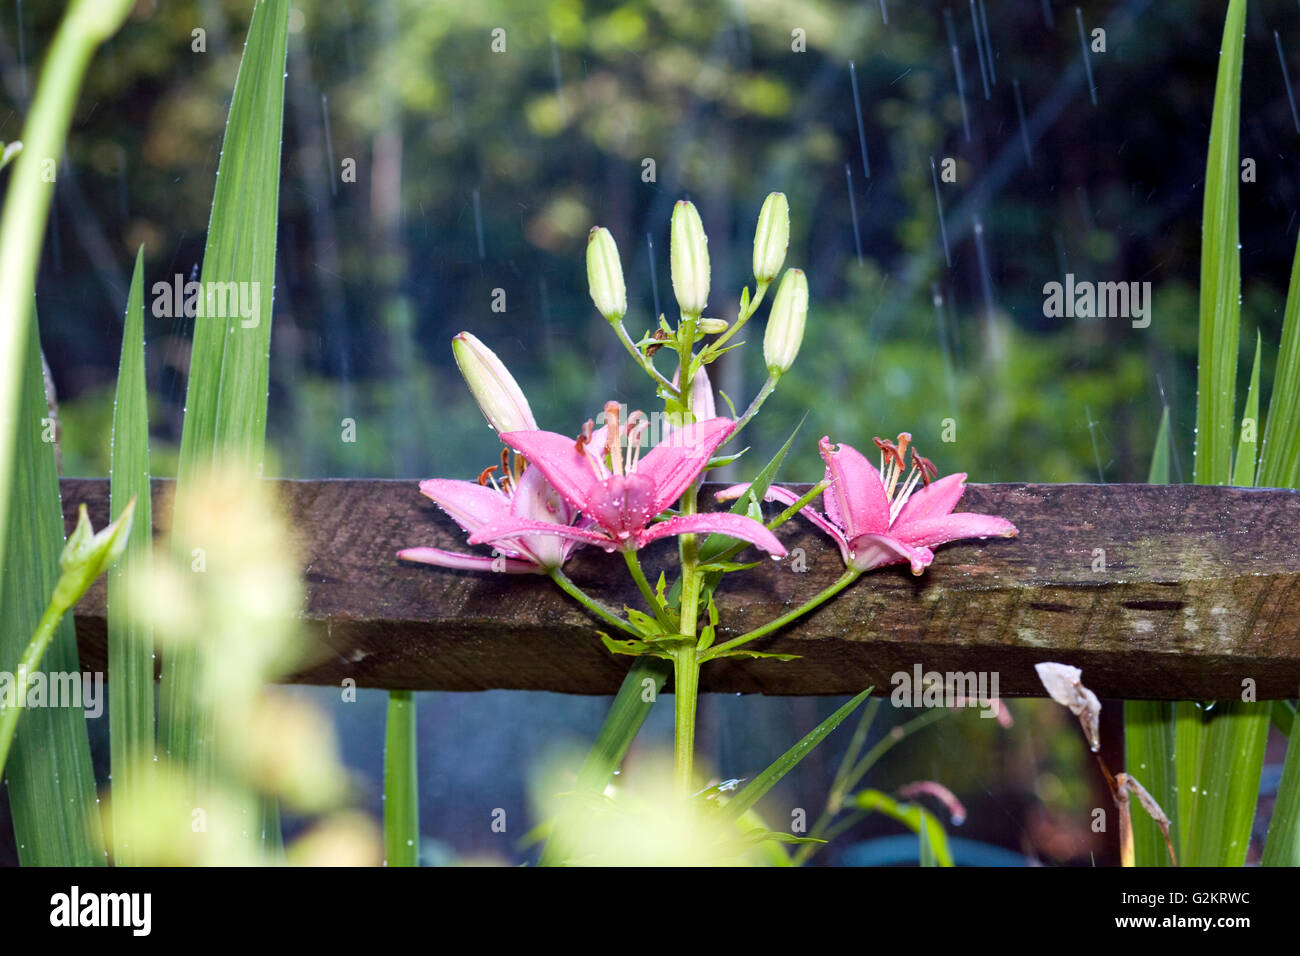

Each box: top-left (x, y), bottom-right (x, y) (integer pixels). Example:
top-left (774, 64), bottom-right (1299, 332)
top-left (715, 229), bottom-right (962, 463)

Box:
top-left (398, 449), bottom-right (589, 574)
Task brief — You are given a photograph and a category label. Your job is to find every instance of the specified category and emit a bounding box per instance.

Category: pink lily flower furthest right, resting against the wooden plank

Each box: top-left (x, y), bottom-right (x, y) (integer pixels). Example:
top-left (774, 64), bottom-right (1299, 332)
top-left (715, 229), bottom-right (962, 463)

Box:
top-left (716, 432), bottom-right (1019, 575)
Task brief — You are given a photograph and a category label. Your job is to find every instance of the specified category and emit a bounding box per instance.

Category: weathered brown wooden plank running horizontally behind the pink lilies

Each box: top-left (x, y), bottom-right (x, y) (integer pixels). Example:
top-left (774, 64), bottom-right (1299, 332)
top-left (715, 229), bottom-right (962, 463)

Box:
top-left (62, 479), bottom-right (1300, 700)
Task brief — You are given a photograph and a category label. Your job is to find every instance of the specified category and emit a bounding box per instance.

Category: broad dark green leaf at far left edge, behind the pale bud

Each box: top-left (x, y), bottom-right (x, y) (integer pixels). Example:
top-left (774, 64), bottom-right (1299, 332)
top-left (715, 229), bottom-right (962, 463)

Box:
top-left (0, 317), bottom-right (104, 866)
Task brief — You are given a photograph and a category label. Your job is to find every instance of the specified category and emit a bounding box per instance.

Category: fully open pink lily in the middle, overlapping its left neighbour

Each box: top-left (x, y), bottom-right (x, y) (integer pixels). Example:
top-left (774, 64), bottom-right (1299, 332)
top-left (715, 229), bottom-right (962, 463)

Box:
top-left (469, 402), bottom-right (785, 558)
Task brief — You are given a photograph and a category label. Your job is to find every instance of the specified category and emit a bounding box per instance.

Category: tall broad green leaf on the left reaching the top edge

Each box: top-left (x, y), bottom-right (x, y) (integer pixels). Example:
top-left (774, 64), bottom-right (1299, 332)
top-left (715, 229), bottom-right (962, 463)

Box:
top-left (159, 0), bottom-right (289, 769)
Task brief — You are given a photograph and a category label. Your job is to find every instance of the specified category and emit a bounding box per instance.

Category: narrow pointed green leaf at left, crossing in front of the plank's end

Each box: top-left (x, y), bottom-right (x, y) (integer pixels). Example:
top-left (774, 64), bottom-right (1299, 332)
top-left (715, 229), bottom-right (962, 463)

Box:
top-left (108, 248), bottom-right (155, 866)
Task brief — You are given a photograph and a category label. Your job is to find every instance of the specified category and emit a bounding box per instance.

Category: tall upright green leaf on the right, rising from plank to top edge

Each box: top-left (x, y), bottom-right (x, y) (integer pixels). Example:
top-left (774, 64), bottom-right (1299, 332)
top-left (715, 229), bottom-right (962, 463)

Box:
top-left (1192, 0), bottom-right (1245, 485)
